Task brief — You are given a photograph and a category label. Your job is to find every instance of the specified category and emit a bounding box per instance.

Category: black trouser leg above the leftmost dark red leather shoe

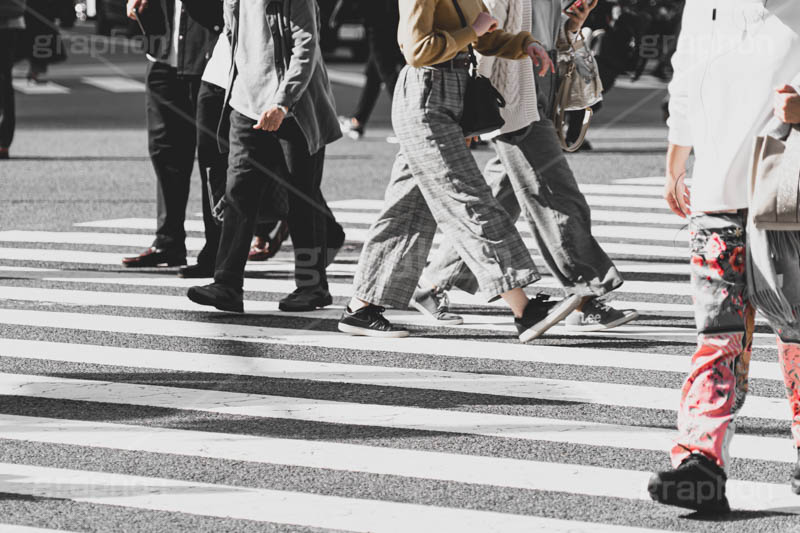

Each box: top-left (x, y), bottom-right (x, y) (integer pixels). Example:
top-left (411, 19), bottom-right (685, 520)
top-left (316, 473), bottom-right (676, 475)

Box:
top-left (146, 63), bottom-right (200, 253)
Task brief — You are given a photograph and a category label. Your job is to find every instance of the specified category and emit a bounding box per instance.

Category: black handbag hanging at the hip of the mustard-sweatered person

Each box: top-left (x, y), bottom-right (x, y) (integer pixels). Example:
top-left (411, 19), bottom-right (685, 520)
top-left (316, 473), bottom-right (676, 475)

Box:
top-left (453, 0), bottom-right (506, 137)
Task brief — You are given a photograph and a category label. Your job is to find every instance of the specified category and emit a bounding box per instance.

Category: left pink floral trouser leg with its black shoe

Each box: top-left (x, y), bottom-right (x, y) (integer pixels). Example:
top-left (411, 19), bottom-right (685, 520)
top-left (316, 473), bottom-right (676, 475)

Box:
top-left (649, 214), bottom-right (755, 511)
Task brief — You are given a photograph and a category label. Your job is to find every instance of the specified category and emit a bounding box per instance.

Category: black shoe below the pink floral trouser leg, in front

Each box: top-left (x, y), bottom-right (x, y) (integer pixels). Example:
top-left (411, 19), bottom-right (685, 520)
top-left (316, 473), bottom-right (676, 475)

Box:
top-left (647, 453), bottom-right (731, 513)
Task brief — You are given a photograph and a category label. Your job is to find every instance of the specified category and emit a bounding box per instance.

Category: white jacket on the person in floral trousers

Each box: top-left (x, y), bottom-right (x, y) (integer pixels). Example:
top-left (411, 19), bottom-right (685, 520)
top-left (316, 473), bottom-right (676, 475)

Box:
top-left (668, 0), bottom-right (800, 213)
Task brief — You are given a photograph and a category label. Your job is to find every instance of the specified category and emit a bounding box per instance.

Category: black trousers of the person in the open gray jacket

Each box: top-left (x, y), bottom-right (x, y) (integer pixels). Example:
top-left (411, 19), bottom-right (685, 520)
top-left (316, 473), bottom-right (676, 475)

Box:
top-left (214, 110), bottom-right (328, 288)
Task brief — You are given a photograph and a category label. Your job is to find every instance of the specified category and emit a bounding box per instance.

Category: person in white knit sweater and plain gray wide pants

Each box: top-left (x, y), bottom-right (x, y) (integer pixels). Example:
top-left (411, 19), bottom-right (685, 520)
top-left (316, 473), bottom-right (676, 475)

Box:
top-left (412, 0), bottom-right (638, 331)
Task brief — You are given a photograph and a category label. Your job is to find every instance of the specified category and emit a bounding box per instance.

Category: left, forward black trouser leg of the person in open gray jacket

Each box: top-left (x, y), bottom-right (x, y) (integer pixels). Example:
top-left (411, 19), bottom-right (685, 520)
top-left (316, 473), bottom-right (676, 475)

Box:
top-left (214, 110), bottom-right (287, 287)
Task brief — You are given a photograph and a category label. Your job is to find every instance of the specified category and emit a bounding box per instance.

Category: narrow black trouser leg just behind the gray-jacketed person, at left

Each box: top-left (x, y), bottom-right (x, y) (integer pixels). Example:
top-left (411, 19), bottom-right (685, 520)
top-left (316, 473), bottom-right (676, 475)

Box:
top-left (197, 82), bottom-right (230, 268)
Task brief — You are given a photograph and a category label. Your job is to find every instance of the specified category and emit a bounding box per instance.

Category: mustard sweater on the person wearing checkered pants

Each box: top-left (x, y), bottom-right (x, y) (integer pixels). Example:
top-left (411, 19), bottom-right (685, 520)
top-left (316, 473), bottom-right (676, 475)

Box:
top-left (397, 0), bottom-right (534, 67)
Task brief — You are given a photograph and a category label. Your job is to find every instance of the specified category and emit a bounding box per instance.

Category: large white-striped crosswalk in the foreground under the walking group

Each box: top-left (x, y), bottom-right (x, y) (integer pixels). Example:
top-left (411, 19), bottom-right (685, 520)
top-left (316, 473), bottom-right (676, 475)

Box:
top-left (0, 178), bottom-right (800, 533)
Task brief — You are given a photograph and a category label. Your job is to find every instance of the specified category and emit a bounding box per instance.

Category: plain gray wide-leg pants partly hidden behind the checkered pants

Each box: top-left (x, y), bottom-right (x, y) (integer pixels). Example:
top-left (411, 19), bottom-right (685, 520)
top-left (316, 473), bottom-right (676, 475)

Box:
top-left (423, 116), bottom-right (622, 296)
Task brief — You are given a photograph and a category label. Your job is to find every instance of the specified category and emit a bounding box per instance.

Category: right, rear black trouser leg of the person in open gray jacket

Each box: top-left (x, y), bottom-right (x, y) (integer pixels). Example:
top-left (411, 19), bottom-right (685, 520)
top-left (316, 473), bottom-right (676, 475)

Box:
top-left (278, 119), bottom-right (328, 289)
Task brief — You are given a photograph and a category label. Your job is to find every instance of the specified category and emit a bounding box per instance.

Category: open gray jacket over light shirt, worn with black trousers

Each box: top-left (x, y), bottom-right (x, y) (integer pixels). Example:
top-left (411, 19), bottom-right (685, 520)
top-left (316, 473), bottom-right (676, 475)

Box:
top-left (225, 0), bottom-right (342, 154)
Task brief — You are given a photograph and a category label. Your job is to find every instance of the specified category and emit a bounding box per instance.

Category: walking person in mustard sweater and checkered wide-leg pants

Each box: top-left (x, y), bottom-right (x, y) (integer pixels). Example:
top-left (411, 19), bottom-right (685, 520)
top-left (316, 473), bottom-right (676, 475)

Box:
top-left (339, 0), bottom-right (578, 342)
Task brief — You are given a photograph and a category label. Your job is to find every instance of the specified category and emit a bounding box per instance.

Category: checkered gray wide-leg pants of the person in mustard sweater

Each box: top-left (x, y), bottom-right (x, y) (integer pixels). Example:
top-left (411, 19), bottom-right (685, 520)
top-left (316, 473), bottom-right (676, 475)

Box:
top-left (353, 66), bottom-right (539, 308)
